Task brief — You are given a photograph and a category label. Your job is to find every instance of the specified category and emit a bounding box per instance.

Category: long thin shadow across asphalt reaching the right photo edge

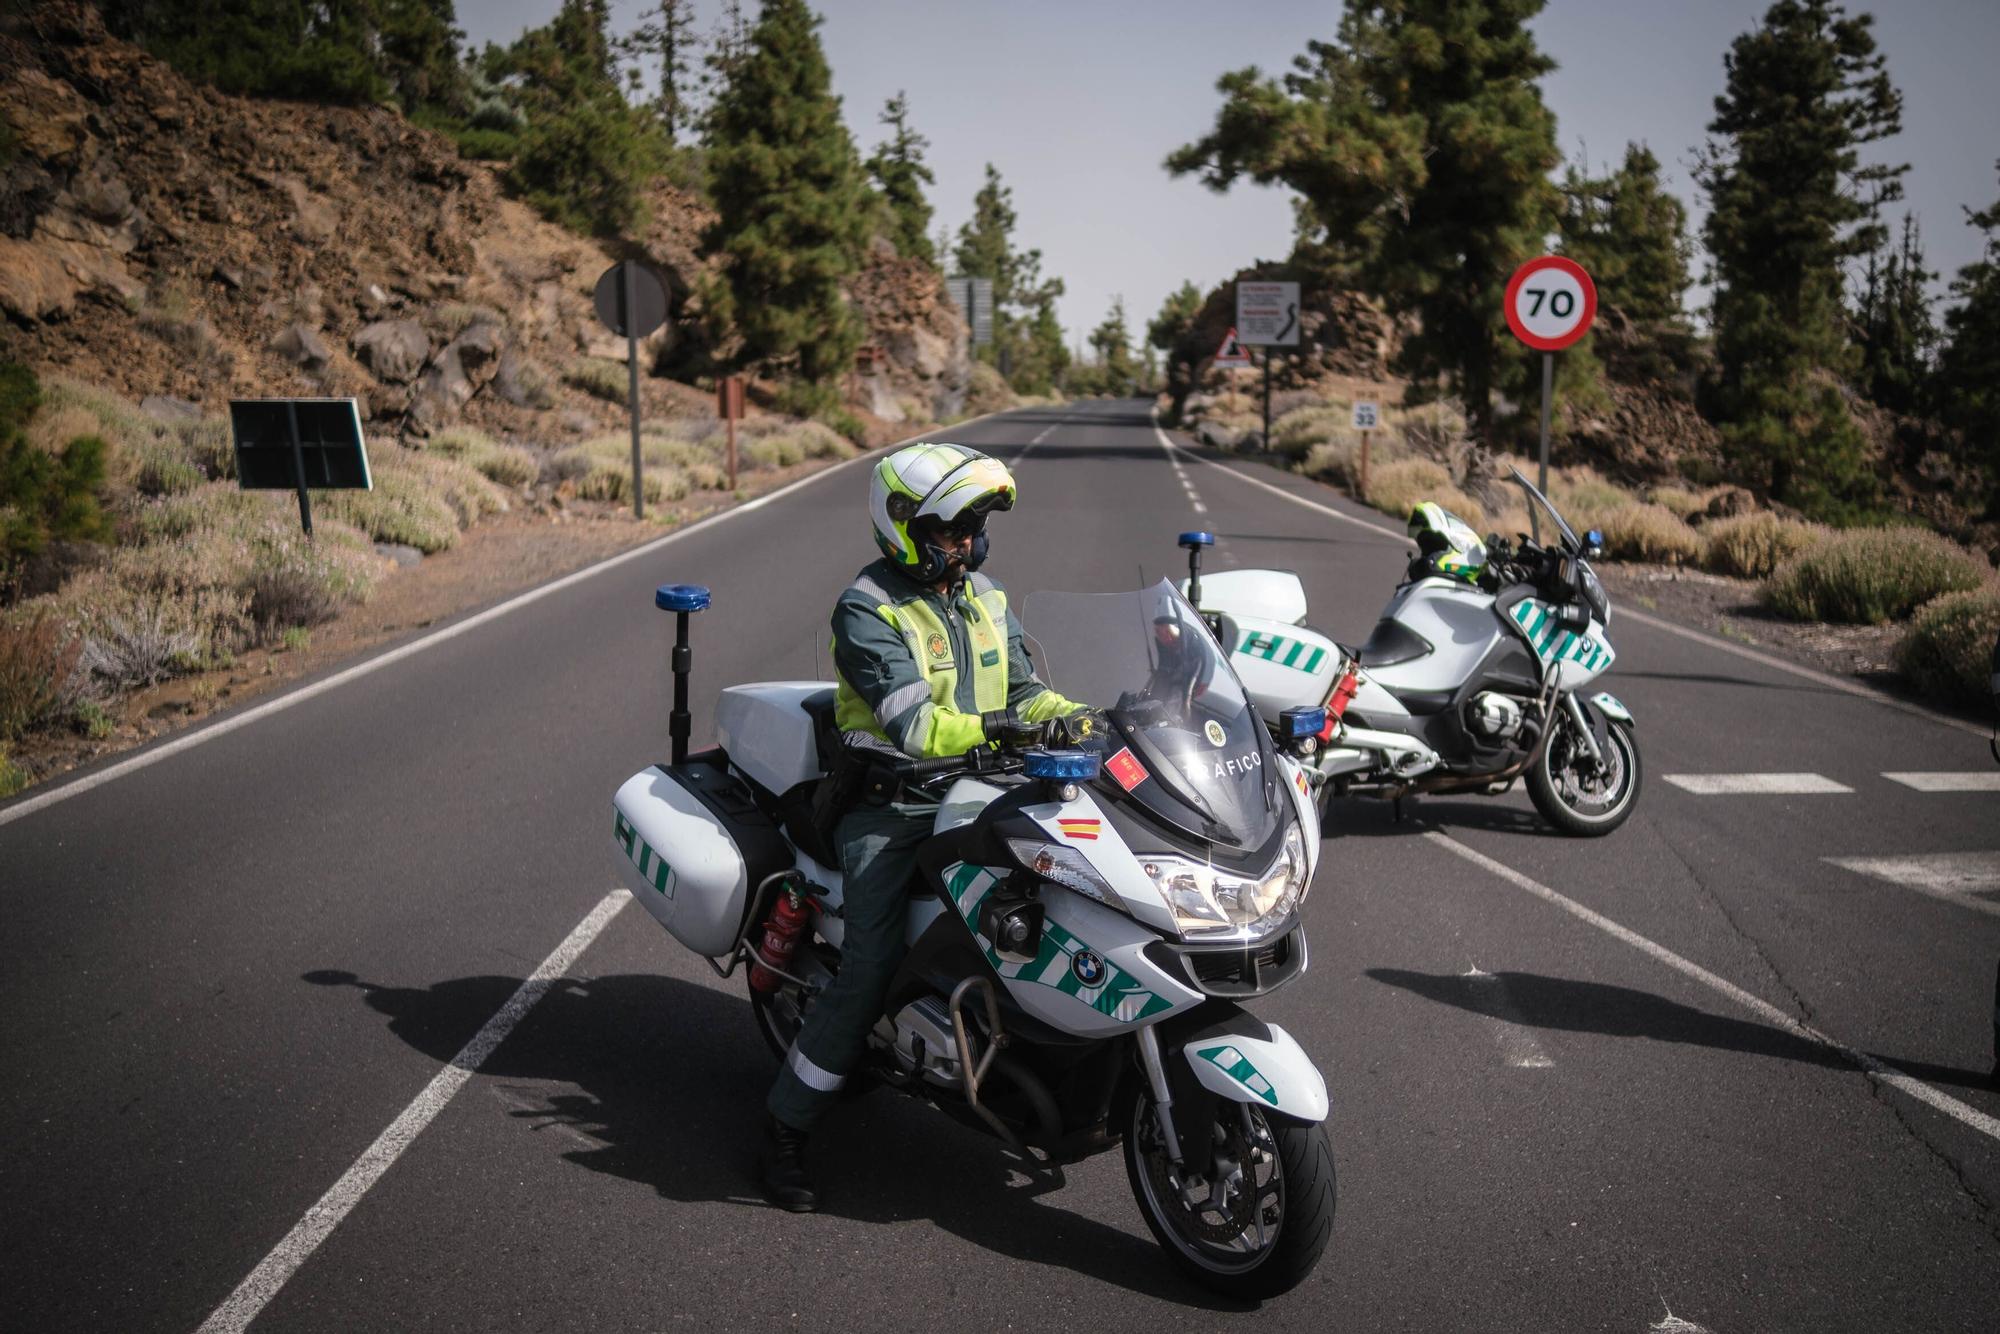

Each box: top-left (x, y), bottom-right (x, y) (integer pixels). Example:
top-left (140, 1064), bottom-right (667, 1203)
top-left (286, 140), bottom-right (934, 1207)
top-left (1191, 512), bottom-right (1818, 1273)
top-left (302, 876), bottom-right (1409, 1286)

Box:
top-left (1368, 968), bottom-right (1992, 1088)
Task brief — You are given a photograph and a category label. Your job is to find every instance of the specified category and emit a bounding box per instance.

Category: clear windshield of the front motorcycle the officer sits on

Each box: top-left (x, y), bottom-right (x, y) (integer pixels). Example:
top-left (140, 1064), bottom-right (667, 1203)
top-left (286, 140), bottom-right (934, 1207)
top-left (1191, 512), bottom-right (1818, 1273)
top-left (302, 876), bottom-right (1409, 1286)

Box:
top-left (1024, 580), bottom-right (1284, 848)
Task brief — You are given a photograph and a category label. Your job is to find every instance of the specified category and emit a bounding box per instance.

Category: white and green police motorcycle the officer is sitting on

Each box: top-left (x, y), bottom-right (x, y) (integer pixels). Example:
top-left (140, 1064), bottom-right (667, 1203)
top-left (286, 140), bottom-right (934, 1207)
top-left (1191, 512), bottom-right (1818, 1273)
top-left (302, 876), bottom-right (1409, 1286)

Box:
top-left (612, 580), bottom-right (1334, 1300)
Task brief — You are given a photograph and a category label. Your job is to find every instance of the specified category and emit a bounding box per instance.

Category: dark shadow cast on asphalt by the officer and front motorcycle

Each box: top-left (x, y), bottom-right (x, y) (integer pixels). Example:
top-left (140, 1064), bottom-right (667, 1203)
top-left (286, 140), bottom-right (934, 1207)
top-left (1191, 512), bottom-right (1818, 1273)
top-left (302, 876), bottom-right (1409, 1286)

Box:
top-left (304, 968), bottom-right (1250, 1312)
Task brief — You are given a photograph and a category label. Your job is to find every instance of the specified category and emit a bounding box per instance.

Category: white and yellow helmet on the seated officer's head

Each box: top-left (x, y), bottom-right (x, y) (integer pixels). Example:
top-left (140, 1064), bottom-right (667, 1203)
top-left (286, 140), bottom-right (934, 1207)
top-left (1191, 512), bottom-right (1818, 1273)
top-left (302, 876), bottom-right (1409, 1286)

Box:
top-left (868, 444), bottom-right (1014, 584)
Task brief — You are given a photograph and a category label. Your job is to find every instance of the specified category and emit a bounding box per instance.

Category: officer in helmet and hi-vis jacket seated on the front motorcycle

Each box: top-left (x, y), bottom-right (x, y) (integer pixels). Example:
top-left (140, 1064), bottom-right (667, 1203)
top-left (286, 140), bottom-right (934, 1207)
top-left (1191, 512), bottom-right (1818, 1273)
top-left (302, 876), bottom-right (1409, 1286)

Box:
top-left (760, 444), bottom-right (1094, 1212)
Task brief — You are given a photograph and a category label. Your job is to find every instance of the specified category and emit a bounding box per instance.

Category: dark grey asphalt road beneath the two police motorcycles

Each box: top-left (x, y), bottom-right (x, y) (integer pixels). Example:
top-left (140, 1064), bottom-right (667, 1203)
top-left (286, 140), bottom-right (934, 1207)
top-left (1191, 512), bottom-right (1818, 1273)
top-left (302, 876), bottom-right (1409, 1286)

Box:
top-left (0, 402), bottom-right (2000, 1334)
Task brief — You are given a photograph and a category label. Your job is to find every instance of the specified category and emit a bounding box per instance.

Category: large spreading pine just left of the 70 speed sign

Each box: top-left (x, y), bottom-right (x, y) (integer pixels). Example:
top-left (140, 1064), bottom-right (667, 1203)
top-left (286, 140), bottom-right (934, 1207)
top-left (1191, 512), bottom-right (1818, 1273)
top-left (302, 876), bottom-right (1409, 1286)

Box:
top-left (1166, 0), bottom-right (1560, 436)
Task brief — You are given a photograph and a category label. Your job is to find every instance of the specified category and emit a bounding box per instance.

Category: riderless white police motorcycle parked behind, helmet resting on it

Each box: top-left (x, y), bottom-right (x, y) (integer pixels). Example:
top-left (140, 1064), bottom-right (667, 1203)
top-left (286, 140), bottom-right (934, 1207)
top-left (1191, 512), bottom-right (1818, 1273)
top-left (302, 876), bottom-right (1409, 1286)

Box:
top-left (1180, 468), bottom-right (1642, 838)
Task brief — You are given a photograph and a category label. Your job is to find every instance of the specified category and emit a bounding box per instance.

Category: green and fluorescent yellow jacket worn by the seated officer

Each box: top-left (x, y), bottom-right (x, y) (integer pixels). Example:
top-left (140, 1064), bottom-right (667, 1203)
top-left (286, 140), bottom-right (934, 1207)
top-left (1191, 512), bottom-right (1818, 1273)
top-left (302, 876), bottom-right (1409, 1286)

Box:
top-left (834, 560), bottom-right (1082, 760)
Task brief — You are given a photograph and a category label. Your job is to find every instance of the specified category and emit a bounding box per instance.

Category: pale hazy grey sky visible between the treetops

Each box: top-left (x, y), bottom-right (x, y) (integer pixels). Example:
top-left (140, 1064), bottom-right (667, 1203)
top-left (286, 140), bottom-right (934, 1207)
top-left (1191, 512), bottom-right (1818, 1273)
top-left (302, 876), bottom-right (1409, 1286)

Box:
top-left (458, 0), bottom-right (2000, 344)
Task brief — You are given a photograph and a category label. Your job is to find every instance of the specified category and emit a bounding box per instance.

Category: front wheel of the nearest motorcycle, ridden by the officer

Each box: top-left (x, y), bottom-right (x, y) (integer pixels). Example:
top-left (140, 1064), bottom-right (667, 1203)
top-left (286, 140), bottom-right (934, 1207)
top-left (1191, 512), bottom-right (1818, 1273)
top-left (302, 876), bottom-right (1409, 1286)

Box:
top-left (1124, 1088), bottom-right (1334, 1302)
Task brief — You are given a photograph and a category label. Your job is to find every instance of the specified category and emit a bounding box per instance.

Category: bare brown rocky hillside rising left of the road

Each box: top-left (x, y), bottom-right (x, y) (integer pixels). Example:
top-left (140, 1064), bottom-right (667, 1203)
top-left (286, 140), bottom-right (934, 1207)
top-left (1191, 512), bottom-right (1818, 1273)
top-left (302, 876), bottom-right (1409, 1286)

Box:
top-left (0, 2), bottom-right (968, 444)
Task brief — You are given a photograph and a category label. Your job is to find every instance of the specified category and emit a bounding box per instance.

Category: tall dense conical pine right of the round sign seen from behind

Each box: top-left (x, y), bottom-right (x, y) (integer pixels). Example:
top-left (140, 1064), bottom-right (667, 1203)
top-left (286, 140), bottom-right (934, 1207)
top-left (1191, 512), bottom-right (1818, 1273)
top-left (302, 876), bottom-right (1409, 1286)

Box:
top-left (702, 0), bottom-right (868, 386)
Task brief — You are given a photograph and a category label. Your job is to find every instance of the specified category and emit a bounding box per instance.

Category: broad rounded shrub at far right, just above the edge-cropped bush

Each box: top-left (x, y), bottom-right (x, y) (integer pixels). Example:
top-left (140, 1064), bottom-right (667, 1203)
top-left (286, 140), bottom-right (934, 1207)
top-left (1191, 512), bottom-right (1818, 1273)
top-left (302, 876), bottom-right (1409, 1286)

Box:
top-left (1764, 528), bottom-right (1990, 624)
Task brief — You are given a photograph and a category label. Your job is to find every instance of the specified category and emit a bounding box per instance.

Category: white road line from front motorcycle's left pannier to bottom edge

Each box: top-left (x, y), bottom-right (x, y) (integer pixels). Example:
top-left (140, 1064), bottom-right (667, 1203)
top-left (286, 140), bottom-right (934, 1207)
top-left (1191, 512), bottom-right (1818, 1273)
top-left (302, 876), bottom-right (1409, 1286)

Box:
top-left (198, 890), bottom-right (632, 1334)
